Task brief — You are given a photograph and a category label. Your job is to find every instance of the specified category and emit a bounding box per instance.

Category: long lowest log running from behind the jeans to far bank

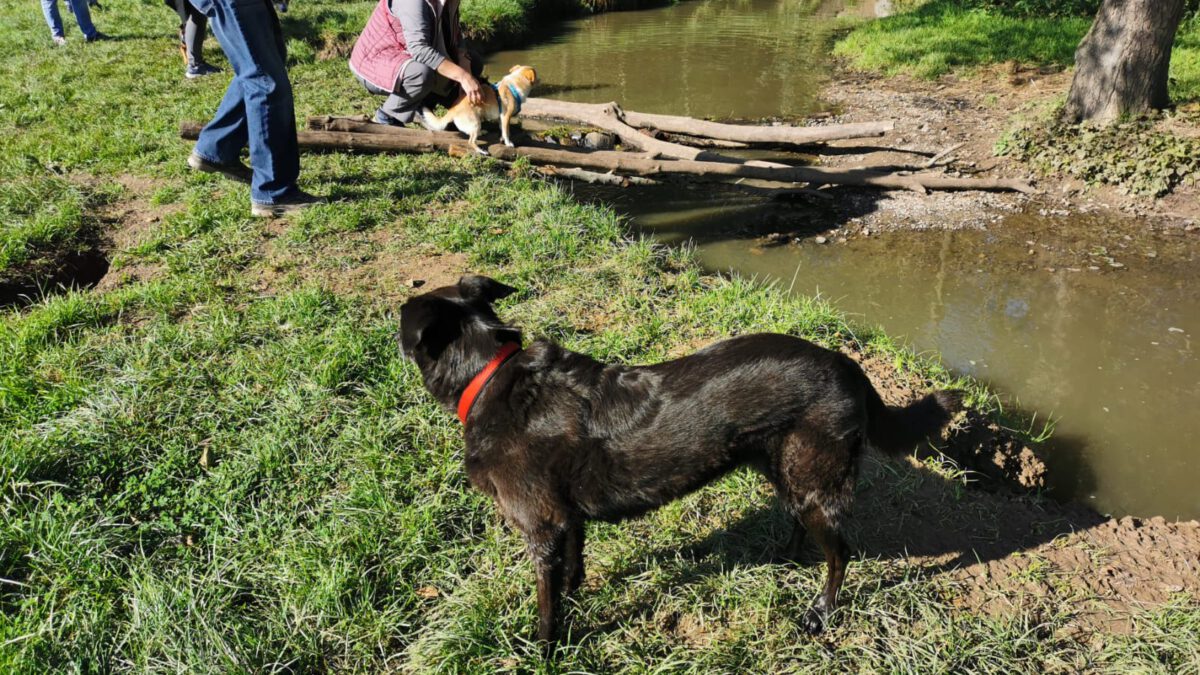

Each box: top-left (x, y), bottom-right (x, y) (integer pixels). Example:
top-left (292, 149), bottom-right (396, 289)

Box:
top-left (180, 123), bottom-right (1036, 193)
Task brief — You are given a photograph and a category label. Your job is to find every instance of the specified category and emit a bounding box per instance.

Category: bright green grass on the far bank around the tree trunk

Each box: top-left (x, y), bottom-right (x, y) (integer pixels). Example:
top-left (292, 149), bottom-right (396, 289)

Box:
top-left (834, 0), bottom-right (1200, 102)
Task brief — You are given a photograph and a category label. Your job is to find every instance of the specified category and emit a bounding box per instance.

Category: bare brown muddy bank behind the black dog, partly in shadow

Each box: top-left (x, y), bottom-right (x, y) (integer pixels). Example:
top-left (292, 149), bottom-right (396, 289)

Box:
top-left (850, 341), bottom-right (1200, 639)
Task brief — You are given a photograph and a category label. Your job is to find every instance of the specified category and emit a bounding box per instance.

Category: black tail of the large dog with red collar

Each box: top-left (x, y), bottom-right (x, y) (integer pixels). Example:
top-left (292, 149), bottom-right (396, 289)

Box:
top-left (866, 384), bottom-right (962, 455)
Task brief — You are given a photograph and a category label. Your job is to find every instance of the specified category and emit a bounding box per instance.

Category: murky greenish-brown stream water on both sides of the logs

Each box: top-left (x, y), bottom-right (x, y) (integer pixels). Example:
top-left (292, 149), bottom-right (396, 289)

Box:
top-left (490, 0), bottom-right (1200, 519)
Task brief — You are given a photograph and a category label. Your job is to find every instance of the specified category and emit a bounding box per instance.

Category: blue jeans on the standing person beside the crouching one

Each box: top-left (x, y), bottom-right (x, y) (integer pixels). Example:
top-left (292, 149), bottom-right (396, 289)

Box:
top-left (192, 0), bottom-right (300, 204)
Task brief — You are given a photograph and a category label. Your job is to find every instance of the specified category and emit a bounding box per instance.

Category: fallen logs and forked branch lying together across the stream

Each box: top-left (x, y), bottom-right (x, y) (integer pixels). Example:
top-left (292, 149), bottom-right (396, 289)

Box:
top-left (180, 98), bottom-right (1034, 193)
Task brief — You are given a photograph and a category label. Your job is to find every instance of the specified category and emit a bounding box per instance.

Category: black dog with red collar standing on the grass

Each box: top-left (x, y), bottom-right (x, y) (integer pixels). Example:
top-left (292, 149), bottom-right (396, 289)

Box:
top-left (400, 276), bottom-right (959, 641)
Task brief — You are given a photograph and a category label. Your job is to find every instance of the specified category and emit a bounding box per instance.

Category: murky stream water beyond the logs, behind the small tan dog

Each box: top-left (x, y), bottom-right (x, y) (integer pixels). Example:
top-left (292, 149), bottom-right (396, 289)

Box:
top-left (488, 0), bottom-right (845, 118)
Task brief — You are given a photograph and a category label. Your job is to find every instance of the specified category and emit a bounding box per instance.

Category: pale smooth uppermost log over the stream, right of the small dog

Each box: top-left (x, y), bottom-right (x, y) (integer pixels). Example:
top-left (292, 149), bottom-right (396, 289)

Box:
top-left (521, 98), bottom-right (895, 145)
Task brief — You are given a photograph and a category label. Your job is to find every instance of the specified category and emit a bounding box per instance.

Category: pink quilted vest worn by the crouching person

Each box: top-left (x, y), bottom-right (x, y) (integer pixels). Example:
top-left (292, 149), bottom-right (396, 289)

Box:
top-left (350, 0), bottom-right (462, 91)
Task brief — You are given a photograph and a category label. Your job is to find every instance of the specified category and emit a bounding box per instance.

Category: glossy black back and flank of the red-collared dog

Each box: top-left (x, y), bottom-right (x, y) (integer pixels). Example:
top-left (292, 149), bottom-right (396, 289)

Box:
top-left (501, 335), bottom-right (866, 520)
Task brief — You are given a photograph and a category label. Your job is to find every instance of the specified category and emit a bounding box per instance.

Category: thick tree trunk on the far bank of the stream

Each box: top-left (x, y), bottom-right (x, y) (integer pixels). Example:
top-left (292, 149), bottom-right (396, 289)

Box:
top-left (1064, 0), bottom-right (1184, 123)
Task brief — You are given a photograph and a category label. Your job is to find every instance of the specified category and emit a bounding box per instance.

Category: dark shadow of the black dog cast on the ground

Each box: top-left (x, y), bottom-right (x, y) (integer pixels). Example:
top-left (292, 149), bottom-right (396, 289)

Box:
top-left (575, 429), bottom-right (1108, 641)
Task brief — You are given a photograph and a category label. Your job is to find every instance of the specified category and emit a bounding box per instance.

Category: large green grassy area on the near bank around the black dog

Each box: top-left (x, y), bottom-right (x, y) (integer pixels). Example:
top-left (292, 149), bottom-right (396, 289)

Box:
top-left (0, 0), bottom-right (1200, 673)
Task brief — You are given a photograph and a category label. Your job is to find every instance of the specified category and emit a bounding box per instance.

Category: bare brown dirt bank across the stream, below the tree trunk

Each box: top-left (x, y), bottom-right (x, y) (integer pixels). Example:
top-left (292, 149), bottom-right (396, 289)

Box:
top-left (806, 65), bottom-right (1200, 232)
